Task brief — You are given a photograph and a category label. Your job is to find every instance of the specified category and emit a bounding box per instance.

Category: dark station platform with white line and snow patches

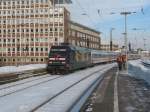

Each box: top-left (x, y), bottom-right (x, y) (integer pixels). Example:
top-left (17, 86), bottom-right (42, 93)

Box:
top-left (80, 68), bottom-right (150, 112)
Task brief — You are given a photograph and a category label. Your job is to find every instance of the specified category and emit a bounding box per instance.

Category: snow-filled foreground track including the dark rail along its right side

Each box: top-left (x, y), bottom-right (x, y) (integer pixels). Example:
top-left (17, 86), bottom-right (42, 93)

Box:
top-left (0, 63), bottom-right (116, 112)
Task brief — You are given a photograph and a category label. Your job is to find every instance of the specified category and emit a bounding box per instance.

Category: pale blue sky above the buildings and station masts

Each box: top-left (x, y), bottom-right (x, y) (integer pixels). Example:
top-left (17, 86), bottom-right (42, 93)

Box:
top-left (66, 0), bottom-right (150, 50)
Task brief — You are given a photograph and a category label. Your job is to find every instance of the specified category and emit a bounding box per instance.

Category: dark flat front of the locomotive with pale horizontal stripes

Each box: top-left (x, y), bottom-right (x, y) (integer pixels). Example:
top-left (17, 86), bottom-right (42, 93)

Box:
top-left (47, 46), bottom-right (70, 74)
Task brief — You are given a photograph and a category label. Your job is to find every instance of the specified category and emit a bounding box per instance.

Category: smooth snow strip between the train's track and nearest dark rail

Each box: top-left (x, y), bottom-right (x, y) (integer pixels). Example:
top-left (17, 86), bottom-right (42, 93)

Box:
top-left (0, 64), bottom-right (115, 112)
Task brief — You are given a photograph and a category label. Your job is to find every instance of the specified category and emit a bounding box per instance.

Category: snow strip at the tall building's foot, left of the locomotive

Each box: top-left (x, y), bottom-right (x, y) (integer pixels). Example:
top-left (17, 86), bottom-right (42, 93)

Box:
top-left (0, 64), bottom-right (46, 74)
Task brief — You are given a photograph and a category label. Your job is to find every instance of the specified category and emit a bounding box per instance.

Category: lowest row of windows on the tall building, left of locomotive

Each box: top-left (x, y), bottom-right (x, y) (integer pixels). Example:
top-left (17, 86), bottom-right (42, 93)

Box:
top-left (0, 58), bottom-right (44, 62)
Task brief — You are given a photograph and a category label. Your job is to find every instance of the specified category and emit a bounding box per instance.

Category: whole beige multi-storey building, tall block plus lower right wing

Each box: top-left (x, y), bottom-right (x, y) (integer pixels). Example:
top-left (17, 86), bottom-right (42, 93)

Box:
top-left (0, 0), bottom-right (100, 65)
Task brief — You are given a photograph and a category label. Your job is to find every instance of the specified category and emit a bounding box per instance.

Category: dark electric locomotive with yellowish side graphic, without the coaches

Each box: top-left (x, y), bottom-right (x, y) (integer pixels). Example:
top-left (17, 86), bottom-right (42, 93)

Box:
top-left (47, 45), bottom-right (91, 74)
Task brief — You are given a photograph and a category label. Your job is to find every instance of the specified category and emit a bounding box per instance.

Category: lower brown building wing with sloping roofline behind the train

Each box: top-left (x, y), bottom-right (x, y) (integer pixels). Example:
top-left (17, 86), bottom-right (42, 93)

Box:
top-left (69, 21), bottom-right (101, 49)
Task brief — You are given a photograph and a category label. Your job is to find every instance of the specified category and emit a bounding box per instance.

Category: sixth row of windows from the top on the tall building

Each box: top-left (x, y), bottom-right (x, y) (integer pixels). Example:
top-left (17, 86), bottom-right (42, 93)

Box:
top-left (0, 27), bottom-right (63, 33)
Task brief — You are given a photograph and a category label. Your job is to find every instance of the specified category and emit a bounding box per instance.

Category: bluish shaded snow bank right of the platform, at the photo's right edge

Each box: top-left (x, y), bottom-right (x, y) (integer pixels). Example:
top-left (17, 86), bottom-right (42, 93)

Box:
top-left (128, 60), bottom-right (150, 84)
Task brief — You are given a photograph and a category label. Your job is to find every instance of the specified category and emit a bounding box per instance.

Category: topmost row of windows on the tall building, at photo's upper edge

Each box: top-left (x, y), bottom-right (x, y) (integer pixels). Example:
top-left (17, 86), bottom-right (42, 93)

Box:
top-left (0, 0), bottom-right (48, 5)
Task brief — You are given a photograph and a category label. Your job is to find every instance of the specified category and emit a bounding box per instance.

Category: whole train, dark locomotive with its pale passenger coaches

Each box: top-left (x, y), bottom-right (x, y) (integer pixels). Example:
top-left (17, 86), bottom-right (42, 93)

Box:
top-left (47, 45), bottom-right (117, 74)
